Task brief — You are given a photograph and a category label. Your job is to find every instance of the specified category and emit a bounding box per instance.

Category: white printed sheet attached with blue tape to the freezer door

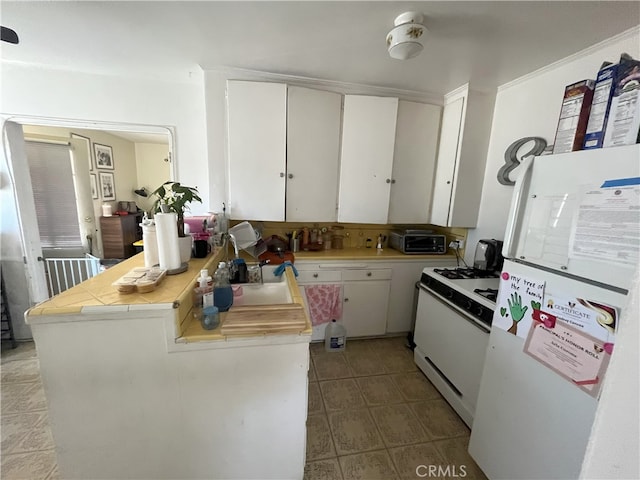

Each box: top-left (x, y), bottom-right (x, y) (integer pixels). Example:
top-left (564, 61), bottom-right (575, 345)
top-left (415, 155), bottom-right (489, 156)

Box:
top-left (569, 182), bottom-right (640, 268)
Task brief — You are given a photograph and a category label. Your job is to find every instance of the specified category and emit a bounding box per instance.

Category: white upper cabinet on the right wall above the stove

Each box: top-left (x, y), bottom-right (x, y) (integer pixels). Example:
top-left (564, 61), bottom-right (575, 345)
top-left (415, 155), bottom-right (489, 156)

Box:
top-left (430, 85), bottom-right (495, 228)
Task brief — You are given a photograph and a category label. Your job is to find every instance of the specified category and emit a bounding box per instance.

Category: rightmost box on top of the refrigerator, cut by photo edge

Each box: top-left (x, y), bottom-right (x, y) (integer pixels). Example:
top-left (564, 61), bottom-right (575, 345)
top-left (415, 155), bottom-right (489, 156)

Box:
top-left (603, 58), bottom-right (640, 147)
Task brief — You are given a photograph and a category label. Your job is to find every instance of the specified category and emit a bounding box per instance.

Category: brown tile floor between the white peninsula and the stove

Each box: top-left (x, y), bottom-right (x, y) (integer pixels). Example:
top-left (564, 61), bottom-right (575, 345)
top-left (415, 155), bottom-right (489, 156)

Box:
top-left (304, 337), bottom-right (486, 480)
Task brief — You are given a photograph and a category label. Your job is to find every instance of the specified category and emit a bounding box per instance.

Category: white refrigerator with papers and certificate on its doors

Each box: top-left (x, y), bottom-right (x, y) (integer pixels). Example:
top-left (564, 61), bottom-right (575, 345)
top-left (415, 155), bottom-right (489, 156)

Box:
top-left (469, 145), bottom-right (640, 480)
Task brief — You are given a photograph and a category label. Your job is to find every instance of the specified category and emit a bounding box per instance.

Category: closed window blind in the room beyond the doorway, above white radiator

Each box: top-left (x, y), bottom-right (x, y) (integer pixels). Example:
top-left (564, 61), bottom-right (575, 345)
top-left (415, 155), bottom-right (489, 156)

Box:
top-left (25, 142), bottom-right (82, 248)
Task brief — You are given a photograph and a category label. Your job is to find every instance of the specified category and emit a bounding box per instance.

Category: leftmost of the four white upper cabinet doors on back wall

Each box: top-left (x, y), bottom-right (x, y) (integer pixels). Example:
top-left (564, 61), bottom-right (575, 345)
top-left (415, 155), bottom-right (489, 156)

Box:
top-left (227, 80), bottom-right (287, 221)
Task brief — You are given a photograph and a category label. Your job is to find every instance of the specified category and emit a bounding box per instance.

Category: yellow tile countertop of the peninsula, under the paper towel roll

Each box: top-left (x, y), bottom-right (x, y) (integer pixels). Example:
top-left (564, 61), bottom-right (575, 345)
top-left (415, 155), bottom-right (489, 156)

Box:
top-left (26, 252), bottom-right (219, 323)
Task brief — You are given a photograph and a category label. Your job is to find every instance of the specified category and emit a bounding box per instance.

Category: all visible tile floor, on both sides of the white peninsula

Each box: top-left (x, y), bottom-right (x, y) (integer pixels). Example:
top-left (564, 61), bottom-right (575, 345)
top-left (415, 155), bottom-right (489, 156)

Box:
top-left (0, 338), bottom-right (486, 480)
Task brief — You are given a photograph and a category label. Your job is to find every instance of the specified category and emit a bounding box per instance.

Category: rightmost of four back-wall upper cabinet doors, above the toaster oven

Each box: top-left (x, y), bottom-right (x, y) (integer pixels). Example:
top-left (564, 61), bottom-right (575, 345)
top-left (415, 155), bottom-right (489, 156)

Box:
top-left (388, 100), bottom-right (442, 223)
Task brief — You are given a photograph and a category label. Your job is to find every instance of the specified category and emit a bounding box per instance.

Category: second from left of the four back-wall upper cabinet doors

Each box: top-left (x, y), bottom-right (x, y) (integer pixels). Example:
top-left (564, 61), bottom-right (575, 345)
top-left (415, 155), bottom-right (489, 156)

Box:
top-left (286, 86), bottom-right (342, 222)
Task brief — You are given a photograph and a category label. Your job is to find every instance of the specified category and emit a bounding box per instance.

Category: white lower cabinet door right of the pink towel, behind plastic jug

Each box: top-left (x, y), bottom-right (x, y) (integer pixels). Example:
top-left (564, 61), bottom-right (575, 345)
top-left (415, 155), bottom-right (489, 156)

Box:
top-left (342, 280), bottom-right (391, 337)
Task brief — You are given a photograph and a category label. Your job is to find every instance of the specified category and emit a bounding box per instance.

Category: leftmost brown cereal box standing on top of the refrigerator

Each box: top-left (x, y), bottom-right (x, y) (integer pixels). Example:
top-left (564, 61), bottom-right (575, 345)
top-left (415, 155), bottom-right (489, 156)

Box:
top-left (553, 80), bottom-right (595, 154)
